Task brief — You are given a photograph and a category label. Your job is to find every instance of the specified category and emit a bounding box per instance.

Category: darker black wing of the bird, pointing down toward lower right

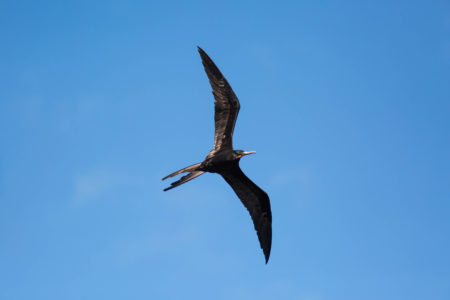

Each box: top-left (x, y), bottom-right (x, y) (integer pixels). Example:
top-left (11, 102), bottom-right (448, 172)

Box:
top-left (220, 162), bottom-right (272, 263)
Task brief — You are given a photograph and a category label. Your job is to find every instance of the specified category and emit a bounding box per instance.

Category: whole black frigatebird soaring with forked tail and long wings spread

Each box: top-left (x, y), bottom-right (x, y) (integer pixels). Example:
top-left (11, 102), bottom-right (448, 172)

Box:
top-left (163, 47), bottom-right (272, 264)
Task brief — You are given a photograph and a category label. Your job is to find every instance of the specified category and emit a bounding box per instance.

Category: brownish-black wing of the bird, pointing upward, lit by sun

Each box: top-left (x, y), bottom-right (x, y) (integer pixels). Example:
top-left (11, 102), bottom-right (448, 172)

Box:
top-left (198, 47), bottom-right (240, 152)
